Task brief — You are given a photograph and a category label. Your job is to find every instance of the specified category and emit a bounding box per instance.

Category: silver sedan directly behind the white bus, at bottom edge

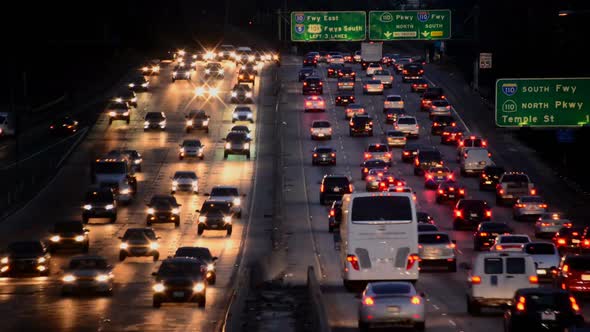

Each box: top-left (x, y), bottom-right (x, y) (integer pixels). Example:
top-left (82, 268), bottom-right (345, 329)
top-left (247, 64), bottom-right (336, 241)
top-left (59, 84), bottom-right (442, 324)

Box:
top-left (358, 282), bottom-right (425, 331)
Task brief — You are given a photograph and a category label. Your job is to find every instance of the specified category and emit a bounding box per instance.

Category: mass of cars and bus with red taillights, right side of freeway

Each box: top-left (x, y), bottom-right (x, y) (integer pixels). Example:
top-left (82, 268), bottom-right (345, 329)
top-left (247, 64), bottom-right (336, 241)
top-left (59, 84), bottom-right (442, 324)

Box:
top-left (298, 51), bottom-right (590, 331)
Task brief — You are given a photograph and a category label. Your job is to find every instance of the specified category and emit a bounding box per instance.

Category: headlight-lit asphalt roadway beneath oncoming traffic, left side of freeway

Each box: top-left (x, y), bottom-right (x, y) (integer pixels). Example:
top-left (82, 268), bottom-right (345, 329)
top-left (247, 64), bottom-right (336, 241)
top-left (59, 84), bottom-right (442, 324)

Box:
top-left (0, 58), bottom-right (271, 331)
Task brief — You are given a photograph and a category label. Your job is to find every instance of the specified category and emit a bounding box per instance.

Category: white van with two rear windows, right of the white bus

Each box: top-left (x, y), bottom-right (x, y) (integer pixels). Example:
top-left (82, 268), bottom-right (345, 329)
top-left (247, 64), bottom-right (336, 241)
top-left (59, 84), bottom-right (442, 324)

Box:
top-left (467, 252), bottom-right (539, 315)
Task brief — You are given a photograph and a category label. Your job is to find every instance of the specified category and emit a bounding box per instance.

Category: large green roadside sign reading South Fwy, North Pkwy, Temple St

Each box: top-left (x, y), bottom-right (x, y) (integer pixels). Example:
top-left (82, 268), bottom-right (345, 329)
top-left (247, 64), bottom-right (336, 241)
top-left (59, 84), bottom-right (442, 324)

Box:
top-left (496, 78), bottom-right (590, 127)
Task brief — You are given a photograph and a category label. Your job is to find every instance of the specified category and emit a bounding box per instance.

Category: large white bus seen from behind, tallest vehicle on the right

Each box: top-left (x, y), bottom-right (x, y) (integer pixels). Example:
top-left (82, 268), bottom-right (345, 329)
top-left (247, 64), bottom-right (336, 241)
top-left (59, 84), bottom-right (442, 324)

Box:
top-left (340, 192), bottom-right (419, 289)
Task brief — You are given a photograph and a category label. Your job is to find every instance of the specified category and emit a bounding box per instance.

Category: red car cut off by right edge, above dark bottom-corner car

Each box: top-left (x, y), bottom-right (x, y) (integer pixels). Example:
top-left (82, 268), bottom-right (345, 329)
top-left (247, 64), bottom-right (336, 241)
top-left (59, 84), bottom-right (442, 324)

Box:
top-left (555, 255), bottom-right (590, 293)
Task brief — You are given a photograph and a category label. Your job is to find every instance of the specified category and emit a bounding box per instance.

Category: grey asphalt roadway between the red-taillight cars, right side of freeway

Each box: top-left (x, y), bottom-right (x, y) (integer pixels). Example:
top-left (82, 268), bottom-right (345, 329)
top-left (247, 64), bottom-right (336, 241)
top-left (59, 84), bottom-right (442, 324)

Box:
top-left (280, 57), bottom-right (588, 331)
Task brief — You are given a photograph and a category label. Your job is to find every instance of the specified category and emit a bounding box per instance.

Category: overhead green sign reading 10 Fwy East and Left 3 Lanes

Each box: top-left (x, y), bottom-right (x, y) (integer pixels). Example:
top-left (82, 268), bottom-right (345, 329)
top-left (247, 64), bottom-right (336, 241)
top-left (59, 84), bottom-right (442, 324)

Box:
top-left (291, 11), bottom-right (367, 42)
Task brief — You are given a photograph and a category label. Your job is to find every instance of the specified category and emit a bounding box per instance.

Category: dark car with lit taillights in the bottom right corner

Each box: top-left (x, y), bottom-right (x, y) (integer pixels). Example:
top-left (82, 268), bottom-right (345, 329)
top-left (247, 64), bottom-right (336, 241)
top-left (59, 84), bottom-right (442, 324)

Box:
top-left (504, 288), bottom-right (584, 332)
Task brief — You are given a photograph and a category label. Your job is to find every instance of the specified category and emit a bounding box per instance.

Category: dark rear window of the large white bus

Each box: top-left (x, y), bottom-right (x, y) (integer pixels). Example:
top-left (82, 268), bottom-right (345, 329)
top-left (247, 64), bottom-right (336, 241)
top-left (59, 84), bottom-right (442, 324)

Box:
top-left (351, 196), bottom-right (412, 224)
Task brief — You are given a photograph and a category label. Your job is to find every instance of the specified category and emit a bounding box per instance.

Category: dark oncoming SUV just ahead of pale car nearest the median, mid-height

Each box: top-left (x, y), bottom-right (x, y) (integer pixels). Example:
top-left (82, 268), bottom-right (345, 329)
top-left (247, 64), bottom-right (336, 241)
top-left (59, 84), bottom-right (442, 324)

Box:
top-left (196, 200), bottom-right (234, 236)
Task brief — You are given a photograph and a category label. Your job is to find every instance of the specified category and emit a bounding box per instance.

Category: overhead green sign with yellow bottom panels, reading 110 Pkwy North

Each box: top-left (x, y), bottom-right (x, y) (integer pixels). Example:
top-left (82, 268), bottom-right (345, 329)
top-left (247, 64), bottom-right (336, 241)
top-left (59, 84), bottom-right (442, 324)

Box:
top-left (369, 9), bottom-right (451, 41)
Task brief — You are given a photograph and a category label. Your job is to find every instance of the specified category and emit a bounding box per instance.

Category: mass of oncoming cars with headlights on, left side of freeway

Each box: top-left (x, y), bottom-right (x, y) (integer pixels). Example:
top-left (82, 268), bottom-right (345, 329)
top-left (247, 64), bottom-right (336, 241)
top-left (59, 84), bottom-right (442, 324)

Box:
top-left (0, 45), bottom-right (280, 308)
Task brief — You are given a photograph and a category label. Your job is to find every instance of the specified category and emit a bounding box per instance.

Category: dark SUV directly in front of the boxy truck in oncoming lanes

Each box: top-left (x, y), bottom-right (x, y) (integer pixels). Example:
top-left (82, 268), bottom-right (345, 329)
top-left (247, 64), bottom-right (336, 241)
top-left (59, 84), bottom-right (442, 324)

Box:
top-left (82, 187), bottom-right (117, 224)
